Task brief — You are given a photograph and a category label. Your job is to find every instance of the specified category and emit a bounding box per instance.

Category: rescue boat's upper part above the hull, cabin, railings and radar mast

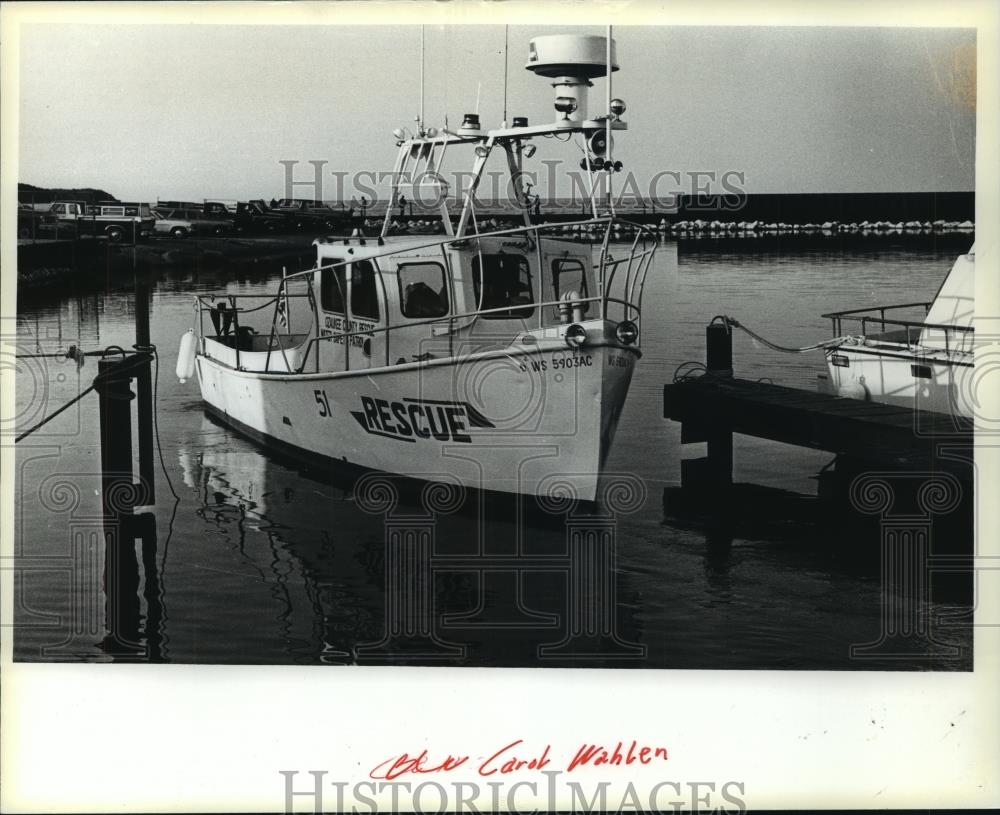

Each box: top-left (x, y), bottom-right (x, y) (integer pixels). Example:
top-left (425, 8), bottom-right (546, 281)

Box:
top-left (198, 35), bottom-right (656, 380)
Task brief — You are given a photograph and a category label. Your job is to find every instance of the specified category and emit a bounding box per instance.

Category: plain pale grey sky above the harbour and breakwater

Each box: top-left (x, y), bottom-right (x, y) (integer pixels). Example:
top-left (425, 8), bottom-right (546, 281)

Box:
top-left (19, 24), bottom-right (975, 200)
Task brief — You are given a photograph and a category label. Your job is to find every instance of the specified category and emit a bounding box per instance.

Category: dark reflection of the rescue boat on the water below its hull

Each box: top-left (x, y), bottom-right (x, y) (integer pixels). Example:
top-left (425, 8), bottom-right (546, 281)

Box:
top-left (178, 417), bottom-right (645, 665)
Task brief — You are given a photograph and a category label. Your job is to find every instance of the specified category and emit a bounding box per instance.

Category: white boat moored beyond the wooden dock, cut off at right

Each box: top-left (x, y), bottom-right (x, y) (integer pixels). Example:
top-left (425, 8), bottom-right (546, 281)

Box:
top-left (820, 246), bottom-right (976, 417)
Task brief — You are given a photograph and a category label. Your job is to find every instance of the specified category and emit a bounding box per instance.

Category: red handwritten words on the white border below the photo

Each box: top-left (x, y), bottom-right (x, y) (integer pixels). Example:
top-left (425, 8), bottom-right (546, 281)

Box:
top-left (368, 739), bottom-right (667, 781)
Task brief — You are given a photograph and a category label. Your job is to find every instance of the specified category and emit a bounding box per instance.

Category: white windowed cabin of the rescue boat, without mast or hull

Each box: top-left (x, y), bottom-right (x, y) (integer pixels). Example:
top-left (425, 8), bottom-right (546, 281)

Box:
top-left (304, 235), bottom-right (597, 370)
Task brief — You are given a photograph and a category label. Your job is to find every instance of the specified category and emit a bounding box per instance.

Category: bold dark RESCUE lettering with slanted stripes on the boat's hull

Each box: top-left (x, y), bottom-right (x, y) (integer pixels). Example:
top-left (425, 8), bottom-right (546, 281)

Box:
top-left (351, 396), bottom-right (496, 444)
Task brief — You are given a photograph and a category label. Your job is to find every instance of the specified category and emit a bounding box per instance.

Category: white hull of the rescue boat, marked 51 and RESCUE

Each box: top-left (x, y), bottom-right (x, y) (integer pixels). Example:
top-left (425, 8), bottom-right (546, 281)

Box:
top-left (197, 328), bottom-right (638, 501)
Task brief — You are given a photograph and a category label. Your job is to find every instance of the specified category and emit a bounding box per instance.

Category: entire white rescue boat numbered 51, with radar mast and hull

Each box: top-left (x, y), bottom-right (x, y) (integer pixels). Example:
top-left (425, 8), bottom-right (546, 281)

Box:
top-left (178, 35), bottom-right (656, 501)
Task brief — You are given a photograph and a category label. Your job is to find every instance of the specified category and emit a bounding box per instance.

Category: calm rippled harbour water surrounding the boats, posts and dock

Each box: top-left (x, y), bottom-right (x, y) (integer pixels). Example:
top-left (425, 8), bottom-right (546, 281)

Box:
top-left (15, 239), bottom-right (972, 670)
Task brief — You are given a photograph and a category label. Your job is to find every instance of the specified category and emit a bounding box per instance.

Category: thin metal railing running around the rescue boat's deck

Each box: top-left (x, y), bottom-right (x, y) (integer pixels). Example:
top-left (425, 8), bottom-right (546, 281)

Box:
top-left (197, 216), bottom-right (658, 373)
